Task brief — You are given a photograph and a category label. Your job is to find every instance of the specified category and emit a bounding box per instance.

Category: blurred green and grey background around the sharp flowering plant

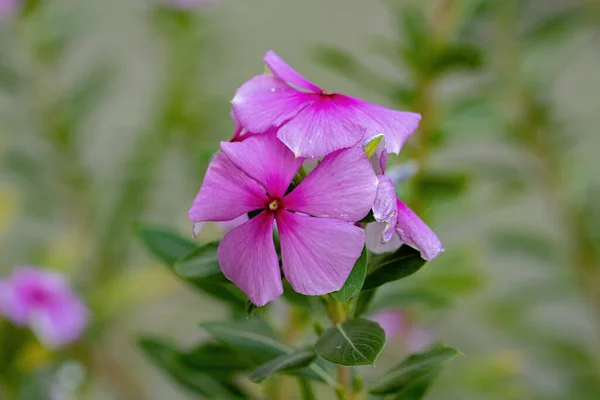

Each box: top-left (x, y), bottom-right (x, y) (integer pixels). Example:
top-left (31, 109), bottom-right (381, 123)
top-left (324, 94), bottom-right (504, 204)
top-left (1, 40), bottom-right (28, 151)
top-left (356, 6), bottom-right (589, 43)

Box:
top-left (0, 0), bottom-right (600, 400)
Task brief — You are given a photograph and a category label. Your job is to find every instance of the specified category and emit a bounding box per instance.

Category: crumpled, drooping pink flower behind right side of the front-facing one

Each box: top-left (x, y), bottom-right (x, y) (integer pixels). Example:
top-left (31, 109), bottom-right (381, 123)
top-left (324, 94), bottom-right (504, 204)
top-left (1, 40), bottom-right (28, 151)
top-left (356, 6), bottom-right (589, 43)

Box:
top-left (365, 150), bottom-right (444, 260)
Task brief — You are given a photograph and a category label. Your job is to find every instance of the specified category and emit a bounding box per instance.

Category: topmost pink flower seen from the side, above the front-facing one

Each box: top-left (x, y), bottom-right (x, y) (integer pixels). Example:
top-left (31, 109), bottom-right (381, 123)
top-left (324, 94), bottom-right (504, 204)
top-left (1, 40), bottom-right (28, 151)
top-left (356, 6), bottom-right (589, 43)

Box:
top-left (232, 50), bottom-right (421, 158)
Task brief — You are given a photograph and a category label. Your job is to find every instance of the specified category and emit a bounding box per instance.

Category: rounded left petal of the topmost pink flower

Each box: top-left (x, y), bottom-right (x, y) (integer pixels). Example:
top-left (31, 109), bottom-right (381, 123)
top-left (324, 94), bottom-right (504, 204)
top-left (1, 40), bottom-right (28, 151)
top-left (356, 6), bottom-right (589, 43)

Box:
top-left (231, 75), bottom-right (314, 133)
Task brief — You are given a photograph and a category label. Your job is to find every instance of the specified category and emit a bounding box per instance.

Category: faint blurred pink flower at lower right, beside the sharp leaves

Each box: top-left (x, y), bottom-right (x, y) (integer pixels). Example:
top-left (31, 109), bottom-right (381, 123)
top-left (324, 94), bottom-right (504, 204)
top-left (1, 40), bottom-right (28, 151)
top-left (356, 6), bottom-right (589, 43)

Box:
top-left (369, 309), bottom-right (432, 353)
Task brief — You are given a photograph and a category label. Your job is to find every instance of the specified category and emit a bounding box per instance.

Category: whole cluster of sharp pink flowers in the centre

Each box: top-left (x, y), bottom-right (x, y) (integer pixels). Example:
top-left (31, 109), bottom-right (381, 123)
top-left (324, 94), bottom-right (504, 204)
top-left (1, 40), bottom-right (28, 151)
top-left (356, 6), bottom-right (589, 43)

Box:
top-left (189, 51), bottom-right (442, 306)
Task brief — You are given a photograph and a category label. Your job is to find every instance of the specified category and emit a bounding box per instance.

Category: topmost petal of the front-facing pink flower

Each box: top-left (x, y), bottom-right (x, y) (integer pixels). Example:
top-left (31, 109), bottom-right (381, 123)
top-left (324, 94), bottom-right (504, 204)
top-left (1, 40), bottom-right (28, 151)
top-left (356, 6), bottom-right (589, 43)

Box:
top-left (221, 134), bottom-right (303, 197)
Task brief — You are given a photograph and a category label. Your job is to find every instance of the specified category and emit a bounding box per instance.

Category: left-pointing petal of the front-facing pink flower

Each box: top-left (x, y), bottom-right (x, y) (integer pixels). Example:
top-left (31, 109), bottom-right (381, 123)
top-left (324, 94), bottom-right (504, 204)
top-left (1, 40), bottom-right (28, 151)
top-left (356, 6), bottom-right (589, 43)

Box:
top-left (188, 153), bottom-right (269, 222)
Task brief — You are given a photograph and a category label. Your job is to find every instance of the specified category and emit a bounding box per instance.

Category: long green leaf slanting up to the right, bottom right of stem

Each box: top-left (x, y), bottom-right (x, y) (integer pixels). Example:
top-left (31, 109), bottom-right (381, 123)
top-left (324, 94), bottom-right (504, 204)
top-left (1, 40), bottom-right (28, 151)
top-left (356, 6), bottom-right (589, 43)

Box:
top-left (369, 346), bottom-right (460, 396)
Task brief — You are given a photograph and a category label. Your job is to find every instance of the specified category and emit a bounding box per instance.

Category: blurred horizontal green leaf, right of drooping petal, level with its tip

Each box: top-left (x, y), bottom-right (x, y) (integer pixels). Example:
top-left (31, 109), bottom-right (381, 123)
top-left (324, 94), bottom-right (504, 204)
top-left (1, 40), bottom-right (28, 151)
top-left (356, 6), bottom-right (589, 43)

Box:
top-left (490, 229), bottom-right (560, 263)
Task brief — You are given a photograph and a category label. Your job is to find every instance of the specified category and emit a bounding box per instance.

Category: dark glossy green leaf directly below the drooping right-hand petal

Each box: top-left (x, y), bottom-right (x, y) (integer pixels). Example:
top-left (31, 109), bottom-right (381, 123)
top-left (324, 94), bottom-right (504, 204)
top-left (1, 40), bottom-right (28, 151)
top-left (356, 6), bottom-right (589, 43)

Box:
top-left (363, 245), bottom-right (426, 290)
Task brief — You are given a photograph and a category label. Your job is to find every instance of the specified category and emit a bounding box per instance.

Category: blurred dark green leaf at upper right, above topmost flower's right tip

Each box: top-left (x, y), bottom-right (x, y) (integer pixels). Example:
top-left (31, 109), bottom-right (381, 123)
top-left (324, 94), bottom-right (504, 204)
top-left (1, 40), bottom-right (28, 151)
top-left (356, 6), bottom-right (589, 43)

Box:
top-left (429, 43), bottom-right (483, 76)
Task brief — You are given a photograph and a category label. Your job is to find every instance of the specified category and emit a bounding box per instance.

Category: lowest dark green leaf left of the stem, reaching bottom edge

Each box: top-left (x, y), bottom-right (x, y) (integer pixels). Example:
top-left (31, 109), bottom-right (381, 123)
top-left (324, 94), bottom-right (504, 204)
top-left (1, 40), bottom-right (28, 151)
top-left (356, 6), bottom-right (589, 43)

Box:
top-left (138, 338), bottom-right (244, 399)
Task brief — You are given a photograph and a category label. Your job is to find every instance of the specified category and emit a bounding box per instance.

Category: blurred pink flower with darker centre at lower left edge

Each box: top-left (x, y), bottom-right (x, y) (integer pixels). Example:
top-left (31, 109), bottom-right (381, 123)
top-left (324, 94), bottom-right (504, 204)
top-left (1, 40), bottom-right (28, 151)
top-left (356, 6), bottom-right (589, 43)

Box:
top-left (0, 267), bottom-right (88, 348)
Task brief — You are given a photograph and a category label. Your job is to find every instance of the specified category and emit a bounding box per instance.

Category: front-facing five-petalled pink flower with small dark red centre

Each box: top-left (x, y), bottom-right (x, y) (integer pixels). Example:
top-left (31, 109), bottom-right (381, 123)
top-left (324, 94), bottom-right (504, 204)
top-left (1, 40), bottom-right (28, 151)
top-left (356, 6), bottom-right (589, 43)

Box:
top-left (189, 134), bottom-right (377, 306)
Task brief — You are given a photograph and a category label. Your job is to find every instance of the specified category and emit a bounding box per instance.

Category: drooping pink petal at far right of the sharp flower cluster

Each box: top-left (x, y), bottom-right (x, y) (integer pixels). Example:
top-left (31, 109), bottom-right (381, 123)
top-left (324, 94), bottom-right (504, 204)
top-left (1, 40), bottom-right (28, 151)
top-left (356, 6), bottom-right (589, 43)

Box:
top-left (396, 199), bottom-right (444, 260)
